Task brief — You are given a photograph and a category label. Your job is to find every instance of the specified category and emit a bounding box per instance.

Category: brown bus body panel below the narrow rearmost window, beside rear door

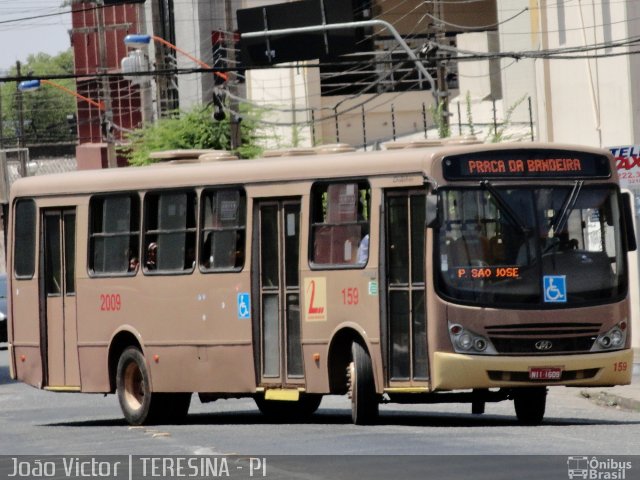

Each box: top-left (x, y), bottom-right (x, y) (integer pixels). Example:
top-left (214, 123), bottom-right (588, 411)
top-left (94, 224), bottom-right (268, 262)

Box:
top-left (9, 277), bottom-right (43, 388)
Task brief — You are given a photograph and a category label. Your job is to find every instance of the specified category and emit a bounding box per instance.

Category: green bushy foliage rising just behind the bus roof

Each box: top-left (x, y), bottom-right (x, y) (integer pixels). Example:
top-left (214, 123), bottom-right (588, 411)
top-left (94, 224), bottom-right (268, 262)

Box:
top-left (121, 106), bottom-right (262, 166)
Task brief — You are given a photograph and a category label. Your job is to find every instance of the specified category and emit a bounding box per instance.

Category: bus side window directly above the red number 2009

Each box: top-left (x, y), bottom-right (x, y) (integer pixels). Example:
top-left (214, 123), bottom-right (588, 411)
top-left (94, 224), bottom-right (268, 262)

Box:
top-left (89, 194), bottom-right (140, 275)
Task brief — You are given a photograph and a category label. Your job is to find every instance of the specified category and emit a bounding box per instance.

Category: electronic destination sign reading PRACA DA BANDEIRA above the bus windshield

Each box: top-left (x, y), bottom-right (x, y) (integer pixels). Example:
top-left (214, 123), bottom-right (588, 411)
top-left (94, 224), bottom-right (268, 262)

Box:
top-left (442, 149), bottom-right (611, 180)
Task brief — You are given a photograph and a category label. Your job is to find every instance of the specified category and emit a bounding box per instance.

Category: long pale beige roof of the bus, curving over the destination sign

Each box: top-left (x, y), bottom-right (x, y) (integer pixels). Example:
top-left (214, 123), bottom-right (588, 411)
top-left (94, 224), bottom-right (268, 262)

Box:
top-left (11, 143), bottom-right (615, 198)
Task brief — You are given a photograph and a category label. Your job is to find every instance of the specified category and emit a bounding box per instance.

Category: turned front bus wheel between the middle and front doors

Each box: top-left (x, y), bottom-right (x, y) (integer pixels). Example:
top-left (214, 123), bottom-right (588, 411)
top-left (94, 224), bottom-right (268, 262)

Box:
top-left (348, 342), bottom-right (379, 425)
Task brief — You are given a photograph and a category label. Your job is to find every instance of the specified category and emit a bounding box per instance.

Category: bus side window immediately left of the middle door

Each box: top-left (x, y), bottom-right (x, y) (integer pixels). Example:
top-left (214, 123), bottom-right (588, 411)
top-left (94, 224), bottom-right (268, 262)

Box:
top-left (200, 189), bottom-right (246, 271)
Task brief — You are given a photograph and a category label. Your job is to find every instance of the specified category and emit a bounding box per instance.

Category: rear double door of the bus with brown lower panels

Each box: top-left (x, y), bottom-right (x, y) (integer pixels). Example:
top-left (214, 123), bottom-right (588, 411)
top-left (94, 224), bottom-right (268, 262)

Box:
top-left (40, 208), bottom-right (80, 389)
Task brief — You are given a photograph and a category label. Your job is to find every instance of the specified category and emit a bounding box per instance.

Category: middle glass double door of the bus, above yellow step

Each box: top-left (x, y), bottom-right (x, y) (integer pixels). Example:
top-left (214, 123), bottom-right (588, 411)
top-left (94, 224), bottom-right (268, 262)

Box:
top-left (252, 199), bottom-right (304, 386)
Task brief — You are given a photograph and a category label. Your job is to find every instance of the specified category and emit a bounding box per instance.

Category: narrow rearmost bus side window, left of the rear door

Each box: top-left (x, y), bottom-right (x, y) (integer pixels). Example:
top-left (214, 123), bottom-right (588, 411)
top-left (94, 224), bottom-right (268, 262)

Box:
top-left (13, 199), bottom-right (36, 278)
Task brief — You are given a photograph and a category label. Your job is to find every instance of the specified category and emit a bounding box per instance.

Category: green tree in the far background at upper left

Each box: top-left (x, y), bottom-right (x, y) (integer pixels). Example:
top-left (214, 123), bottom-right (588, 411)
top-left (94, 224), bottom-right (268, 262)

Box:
top-left (0, 49), bottom-right (76, 145)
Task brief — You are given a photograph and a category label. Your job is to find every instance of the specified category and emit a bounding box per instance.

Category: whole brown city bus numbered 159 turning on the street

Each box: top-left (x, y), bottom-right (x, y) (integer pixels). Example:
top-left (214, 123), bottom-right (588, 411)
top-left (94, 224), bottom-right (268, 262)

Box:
top-left (8, 144), bottom-right (635, 424)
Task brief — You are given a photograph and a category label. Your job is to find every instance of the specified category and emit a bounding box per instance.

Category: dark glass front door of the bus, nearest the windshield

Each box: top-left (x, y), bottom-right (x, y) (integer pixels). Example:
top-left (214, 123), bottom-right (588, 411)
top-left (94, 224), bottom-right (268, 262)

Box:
top-left (382, 190), bottom-right (429, 384)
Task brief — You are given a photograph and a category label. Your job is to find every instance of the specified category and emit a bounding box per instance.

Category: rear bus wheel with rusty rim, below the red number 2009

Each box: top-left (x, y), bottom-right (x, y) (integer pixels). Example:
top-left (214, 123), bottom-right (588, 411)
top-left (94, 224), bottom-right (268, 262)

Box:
top-left (116, 347), bottom-right (165, 425)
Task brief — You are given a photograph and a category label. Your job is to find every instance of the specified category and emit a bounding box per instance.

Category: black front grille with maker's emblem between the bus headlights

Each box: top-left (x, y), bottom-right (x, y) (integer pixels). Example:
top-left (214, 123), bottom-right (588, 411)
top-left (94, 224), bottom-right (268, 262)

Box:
top-left (486, 323), bottom-right (601, 355)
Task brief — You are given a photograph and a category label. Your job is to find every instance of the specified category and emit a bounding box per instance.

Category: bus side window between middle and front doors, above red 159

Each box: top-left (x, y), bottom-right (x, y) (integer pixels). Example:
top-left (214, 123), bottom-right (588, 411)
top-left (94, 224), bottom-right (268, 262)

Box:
top-left (310, 182), bottom-right (371, 267)
